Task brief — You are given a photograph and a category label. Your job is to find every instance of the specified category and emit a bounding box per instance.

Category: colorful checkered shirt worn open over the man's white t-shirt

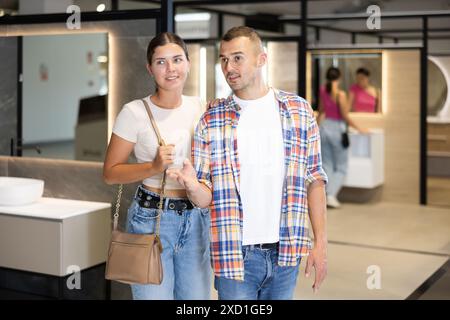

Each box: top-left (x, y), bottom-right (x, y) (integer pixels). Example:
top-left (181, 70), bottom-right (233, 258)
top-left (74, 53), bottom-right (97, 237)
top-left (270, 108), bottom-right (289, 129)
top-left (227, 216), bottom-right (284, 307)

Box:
top-left (192, 89), bottom-right (327, 280)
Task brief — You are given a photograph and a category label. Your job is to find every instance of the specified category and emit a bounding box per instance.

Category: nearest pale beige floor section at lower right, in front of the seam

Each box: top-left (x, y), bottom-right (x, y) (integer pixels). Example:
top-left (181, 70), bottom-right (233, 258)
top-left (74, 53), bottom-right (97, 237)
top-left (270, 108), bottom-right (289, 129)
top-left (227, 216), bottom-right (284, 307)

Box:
top-left (295, 243), bottom-right (447, 299)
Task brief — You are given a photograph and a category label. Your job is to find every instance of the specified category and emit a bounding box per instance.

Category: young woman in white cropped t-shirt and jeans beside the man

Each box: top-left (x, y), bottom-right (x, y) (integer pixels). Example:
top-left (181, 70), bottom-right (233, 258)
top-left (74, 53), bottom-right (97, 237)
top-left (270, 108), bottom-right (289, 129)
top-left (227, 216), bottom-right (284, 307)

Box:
top-left (103, 33), bottom-right (211, 300)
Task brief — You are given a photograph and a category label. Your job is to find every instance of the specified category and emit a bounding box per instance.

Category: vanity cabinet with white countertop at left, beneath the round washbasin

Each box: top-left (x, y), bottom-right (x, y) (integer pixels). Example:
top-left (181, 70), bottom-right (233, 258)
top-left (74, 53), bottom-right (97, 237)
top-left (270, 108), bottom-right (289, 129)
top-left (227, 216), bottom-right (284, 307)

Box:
top-left (0, 197), bottom-right (111, 299)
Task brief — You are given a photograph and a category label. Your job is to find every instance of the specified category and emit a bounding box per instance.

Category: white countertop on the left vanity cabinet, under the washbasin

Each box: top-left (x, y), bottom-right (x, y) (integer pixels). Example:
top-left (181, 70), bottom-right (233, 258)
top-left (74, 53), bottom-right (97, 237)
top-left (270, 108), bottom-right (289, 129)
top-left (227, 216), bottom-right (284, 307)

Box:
top-left (0, 197), bottom-right (111, 220)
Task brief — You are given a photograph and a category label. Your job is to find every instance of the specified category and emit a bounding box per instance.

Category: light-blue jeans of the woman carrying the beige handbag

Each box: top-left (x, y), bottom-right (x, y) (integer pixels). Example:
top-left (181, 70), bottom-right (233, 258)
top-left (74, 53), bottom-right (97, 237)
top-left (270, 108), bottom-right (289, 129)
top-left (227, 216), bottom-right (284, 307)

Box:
top-left (127, 185), bottom-right (211, 300)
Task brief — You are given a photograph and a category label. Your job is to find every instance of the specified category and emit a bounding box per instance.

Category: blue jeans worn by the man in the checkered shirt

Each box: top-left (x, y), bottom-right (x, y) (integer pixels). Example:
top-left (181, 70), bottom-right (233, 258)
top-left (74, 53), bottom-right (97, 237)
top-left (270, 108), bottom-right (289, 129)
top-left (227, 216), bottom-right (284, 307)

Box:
top-left (214, 246), bottom-right (301, 300)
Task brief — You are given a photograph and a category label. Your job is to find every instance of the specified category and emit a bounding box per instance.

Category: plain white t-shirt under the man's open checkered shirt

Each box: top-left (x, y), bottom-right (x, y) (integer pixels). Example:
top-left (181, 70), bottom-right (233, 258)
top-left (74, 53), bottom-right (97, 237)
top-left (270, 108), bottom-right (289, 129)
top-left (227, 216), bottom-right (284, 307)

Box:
top-left (233, 89), bottom-right (285, 245)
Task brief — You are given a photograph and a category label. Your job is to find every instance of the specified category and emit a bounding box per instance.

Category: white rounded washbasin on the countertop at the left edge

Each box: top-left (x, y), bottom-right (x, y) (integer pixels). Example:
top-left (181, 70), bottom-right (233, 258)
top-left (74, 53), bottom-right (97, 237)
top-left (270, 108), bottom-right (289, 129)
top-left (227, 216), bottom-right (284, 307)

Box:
top-left (0, 177), bottom-right (44, 206)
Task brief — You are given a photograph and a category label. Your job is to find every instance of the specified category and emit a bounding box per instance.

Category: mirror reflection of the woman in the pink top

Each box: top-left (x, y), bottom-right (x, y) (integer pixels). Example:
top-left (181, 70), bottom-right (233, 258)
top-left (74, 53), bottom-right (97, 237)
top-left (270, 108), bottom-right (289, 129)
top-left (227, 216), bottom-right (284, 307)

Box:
top-left (349, 68), bottom-right (381, 113)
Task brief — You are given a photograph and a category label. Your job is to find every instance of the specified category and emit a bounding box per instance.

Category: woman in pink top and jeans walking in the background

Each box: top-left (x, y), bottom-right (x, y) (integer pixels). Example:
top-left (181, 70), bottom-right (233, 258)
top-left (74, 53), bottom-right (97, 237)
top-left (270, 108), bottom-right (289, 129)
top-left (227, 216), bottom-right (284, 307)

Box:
top-left (317, 67), bottom-right (367, 208)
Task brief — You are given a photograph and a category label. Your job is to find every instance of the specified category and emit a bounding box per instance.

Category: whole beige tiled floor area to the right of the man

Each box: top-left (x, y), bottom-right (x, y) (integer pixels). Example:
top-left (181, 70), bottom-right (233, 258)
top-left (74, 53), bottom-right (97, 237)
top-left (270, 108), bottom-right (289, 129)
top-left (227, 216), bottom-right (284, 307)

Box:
top-left (213, 203), bottom-right (450, 300)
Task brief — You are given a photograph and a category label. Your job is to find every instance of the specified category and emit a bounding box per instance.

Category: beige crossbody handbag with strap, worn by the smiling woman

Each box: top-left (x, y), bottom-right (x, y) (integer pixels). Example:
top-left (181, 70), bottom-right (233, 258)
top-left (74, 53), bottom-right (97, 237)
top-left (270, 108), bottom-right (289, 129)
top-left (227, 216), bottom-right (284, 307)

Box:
top-left (105, 99), bottom-right (166, 284)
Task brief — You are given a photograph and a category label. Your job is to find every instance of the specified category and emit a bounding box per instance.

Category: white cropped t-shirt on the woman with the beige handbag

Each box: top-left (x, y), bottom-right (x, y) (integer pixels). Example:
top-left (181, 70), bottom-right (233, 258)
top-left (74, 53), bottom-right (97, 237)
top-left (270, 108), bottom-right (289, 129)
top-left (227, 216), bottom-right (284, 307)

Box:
top-left (112, 95), bottom-right (205, 190)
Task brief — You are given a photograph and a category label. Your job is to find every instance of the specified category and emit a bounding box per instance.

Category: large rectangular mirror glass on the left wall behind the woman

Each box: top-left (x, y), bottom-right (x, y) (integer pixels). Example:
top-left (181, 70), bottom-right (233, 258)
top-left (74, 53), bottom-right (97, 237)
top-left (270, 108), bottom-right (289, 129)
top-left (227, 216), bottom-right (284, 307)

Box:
top-left (21, 33), bottom-right (108, 161)
